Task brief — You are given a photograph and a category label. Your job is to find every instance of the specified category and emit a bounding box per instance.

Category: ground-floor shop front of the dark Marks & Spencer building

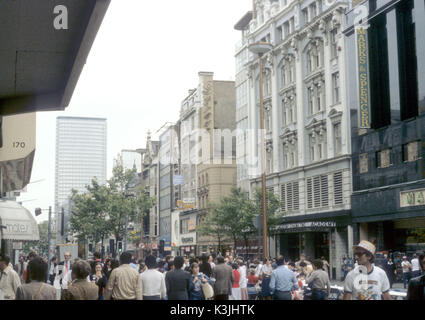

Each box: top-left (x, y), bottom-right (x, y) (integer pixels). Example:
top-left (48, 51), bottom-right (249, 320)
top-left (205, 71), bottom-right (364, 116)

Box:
top-left (353, 182), bottom-right (425, 256)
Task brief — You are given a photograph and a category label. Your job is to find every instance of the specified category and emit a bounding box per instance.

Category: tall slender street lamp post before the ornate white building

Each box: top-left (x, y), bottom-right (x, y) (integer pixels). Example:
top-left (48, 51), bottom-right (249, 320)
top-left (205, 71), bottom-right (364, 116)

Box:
top-left (248, 42), bottom-right (272, 259)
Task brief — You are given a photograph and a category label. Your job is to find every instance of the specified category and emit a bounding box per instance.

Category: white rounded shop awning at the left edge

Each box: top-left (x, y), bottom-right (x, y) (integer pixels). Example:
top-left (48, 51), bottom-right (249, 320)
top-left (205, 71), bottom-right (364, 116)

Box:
top-left (0, 200), bottom-right (40, 241)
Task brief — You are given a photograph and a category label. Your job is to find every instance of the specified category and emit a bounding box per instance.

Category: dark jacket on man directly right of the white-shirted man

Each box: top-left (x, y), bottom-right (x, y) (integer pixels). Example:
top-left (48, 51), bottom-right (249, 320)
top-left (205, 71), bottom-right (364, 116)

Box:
top-left (165, 269), bottom-right (190, 300)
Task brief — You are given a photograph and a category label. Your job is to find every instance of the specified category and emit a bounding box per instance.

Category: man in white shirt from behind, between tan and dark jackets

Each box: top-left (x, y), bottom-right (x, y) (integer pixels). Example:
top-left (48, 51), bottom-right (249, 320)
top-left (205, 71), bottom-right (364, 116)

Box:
top-left (140, 255), bottom-right (167, 300)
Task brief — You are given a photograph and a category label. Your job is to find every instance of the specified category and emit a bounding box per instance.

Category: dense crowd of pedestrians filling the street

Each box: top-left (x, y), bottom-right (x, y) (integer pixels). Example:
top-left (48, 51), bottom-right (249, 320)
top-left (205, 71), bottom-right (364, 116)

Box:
top-left (0, 241), bottom-right (425, 300)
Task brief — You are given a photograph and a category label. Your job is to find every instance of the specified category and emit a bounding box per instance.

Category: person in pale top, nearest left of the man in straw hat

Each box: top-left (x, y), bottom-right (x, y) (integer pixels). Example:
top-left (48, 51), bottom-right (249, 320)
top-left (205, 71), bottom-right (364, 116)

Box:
top-left (305, 259), bottom-right (331, 300)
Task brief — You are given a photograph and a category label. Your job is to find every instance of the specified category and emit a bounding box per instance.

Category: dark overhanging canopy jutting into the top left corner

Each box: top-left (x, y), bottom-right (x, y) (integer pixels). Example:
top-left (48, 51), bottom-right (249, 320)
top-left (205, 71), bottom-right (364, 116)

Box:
top-left (0, 0), bottom-right (110, 116)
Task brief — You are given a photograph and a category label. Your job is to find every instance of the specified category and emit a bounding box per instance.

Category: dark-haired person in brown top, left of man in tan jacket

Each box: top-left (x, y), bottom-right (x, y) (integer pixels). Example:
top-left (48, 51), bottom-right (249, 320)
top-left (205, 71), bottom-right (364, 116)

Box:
top-left (61, 259), bottom-right (99, 300)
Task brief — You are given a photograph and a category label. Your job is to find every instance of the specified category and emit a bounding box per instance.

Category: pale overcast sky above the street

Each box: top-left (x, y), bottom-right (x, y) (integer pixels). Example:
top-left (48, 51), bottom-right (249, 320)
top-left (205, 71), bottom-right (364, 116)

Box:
top-left (18, 0), bottom-right (252, 221)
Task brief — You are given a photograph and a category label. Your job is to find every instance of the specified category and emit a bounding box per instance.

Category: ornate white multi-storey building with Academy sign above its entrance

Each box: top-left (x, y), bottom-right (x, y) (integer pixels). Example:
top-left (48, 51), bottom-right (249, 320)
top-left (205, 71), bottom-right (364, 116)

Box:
top-left (235, 0), bottom-right (352, 277)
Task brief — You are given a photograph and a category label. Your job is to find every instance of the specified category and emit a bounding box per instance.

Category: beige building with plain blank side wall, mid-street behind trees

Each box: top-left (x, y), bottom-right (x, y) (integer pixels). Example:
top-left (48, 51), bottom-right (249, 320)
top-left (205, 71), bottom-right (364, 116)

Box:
top-left (176, 72), bottom-right (236, 255)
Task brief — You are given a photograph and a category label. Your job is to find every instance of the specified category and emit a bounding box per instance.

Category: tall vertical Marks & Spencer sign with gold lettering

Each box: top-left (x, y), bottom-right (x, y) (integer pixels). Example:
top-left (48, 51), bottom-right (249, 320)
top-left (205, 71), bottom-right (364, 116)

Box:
top-left (356, 27), bottom-right (370, 128)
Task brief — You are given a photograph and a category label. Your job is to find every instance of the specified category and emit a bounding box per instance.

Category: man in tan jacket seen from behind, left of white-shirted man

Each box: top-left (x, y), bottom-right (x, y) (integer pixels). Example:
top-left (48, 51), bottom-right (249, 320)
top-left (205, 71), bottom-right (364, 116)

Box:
top-left (104, 251), bottom-right (143, 300)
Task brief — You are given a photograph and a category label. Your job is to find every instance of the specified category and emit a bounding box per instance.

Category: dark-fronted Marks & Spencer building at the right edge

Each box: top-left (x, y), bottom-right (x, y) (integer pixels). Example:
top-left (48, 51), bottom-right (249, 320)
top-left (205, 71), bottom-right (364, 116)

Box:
top-left (344, 0), bottom-right (425, 257)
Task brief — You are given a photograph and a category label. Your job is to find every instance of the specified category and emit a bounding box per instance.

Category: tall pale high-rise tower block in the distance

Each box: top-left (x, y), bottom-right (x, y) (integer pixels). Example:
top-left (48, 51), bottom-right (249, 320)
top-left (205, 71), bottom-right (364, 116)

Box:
top-left (54, 117), bottom-right (107, 244)
